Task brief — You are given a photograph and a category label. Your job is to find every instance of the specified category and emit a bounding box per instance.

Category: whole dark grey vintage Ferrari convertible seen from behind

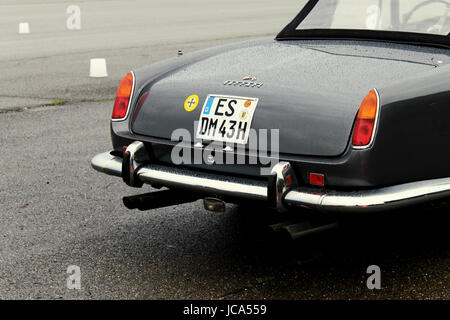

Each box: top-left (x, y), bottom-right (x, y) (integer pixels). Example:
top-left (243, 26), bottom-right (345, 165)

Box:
top-left (92, 0), bottom-right (450, 212)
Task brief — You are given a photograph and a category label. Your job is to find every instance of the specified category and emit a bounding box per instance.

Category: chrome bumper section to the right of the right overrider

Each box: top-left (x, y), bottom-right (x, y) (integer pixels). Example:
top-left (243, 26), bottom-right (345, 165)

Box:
top-left (284, 178), bottom-right (450, 212)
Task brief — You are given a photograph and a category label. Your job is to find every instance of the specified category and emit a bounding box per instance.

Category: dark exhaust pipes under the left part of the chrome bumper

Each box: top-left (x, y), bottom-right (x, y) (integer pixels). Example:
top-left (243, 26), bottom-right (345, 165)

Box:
top-left (122, 190), bottom-right (200, 211)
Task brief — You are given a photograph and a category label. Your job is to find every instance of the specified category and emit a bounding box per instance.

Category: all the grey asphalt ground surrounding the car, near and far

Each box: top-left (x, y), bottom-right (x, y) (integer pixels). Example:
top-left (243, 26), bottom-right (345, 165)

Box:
top-left (0, 0), bottom-right (450, 299)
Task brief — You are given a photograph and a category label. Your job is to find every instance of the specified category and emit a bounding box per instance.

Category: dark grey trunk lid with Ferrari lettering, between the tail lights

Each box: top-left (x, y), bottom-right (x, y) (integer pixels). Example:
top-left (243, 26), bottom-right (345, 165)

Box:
top-left (132, 41), bottom-right (435, 157)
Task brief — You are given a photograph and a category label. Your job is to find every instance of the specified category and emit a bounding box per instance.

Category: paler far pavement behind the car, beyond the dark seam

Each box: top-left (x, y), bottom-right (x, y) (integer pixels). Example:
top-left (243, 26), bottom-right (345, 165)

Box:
top-left (0, 0), bottom-right (304, 110)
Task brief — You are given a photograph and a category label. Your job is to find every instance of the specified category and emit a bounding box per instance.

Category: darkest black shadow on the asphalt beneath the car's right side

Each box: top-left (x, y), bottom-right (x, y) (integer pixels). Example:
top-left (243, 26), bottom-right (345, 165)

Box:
top-left (233, 204), bottom-right (450, 263)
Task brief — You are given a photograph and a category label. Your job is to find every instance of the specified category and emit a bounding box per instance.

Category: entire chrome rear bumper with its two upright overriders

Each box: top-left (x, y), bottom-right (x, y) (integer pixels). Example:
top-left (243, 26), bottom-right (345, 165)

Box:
top-left (91, 152), bottom-right (450, 212)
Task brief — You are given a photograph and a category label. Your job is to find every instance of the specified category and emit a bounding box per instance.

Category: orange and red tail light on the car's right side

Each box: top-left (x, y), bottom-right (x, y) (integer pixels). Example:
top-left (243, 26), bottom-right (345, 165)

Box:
top-left (352, 89), bottom-right (379, 148)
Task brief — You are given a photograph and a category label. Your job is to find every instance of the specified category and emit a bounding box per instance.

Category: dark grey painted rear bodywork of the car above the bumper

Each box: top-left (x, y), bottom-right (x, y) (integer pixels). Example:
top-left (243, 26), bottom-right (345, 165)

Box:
top-left (111, 39), bottom-right (450, 189)
